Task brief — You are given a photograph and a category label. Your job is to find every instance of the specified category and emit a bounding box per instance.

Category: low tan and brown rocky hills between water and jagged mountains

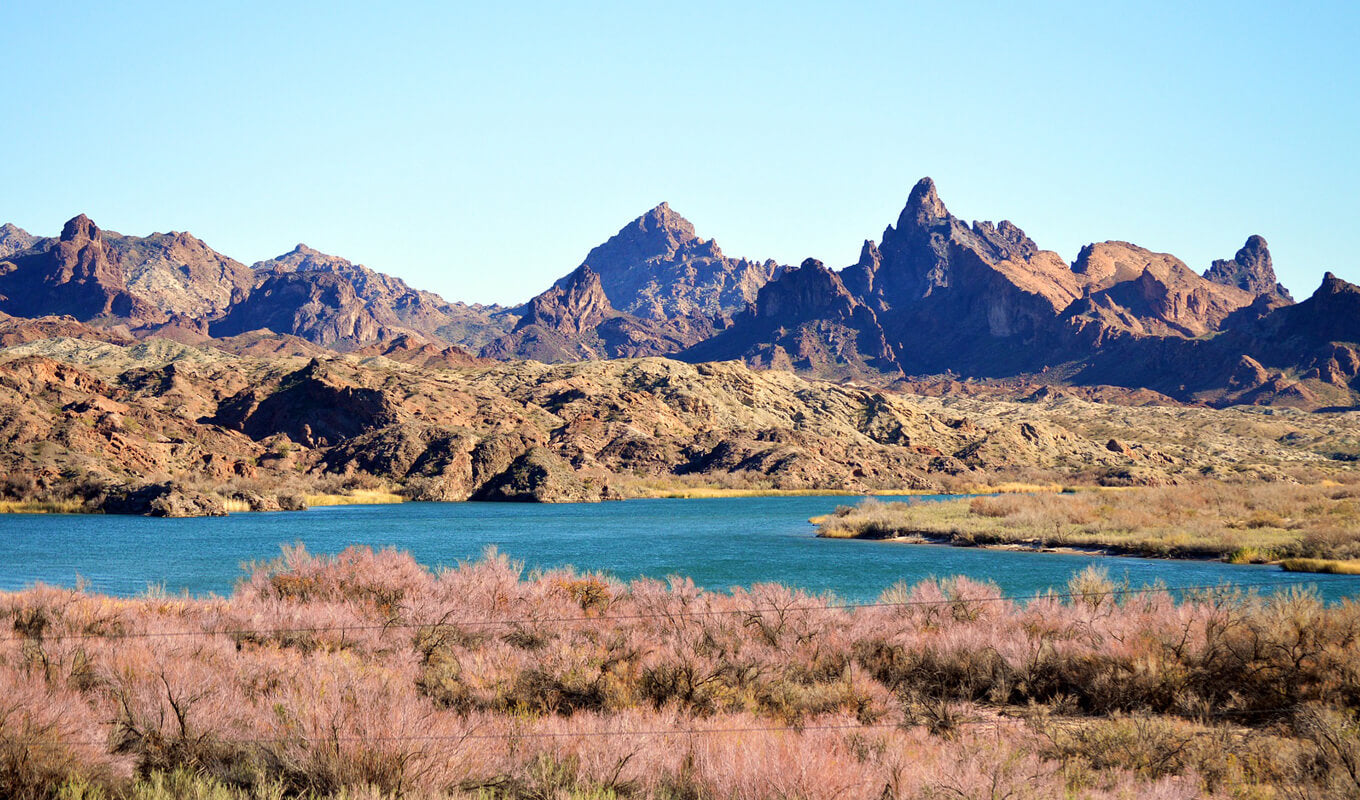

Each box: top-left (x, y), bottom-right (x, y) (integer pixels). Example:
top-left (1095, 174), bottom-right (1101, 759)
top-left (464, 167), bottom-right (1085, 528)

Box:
top-left (0, 322), bottom-right (1355, 513)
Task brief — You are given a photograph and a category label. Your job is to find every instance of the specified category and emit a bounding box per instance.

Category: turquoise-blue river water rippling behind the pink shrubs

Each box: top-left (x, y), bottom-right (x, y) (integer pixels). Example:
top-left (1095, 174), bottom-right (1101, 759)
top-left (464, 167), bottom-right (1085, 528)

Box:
top-left (0, 497), bottom-right (1360, 601)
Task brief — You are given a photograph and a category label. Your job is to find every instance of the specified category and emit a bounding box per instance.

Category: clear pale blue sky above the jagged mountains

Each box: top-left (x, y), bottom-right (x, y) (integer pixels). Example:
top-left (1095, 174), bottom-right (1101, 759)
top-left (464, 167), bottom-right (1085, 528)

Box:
top-left (0, 0), bottom-right (1360, 302)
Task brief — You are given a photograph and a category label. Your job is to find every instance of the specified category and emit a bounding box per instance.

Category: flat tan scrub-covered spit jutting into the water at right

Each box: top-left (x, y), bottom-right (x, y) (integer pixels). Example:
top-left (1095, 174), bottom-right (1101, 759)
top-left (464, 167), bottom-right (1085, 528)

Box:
top-left (816, 482), bottom-right (1360, 563)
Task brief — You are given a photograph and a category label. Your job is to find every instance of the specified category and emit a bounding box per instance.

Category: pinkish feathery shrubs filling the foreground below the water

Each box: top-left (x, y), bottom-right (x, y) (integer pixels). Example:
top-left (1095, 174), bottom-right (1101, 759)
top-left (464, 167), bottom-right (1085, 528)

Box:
top-left (0, 548), bottom-right (1360, 800)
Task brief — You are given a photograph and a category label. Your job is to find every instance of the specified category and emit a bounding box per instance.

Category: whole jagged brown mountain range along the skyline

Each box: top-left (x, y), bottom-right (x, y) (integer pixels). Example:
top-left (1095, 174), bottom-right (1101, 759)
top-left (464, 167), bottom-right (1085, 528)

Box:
top-left (0, 178), bottom-right (1360, 410)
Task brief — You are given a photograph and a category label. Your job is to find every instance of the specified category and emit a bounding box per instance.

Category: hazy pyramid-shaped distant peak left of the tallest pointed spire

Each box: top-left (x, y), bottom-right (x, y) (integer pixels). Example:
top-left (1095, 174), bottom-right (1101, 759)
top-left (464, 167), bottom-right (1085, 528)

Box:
top-left (571, 203), bottom-right (778, 322)
